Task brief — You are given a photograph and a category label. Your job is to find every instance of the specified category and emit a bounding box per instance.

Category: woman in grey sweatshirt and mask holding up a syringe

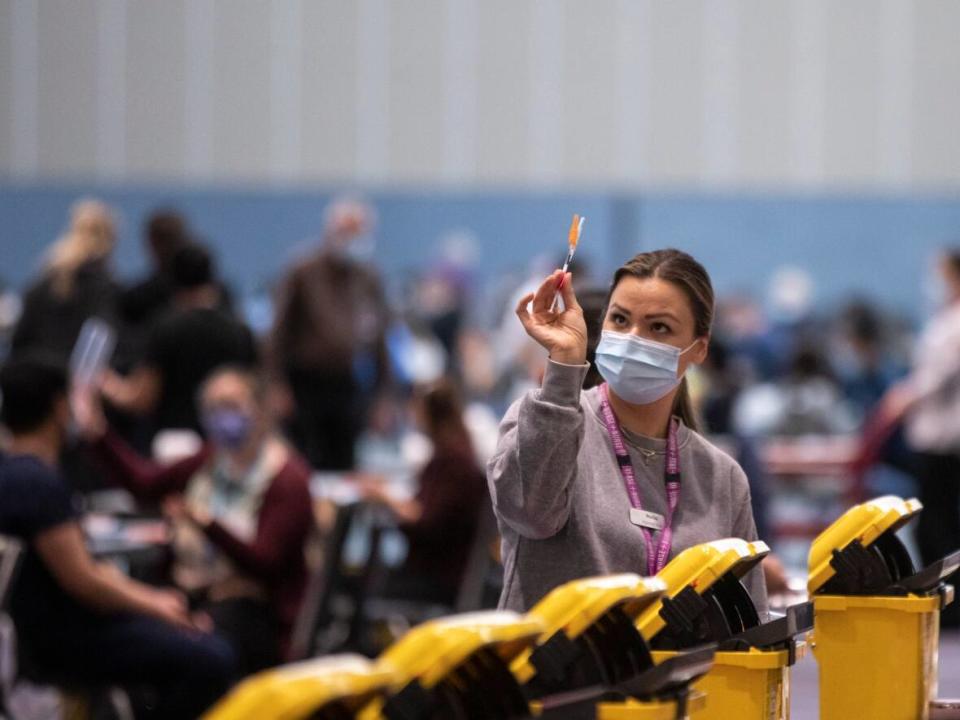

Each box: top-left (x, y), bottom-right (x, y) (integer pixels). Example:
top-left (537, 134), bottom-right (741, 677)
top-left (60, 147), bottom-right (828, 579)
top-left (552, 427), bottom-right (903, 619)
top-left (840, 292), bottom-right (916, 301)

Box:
top-left (487, 250), bottom-right (767, 612)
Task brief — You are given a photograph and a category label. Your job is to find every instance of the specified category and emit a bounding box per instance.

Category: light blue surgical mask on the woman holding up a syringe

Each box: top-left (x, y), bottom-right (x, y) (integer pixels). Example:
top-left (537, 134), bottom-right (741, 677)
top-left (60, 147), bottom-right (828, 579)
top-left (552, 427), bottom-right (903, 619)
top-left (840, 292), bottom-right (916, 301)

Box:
top-left (596, 330), bottom-right (700, 405)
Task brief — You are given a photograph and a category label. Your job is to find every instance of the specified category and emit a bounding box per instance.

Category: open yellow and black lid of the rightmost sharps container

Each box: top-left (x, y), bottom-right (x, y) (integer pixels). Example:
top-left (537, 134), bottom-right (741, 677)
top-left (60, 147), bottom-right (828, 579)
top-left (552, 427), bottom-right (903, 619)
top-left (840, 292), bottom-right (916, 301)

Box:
top-left (807, 495), bottom-right (960, 595)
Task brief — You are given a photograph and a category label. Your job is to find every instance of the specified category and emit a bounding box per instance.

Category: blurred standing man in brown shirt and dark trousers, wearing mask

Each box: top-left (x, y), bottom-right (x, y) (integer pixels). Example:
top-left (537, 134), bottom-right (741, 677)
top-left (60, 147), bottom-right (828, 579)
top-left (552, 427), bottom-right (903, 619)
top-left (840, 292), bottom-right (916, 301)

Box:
top-left (267, 199), bottom-right (390, 470)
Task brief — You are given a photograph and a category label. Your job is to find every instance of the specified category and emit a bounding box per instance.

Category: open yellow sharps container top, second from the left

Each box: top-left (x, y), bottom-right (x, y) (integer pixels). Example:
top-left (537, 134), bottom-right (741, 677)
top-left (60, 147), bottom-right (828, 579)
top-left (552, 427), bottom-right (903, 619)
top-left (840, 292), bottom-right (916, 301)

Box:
top-left (357, 611), bottom-right (544, 720)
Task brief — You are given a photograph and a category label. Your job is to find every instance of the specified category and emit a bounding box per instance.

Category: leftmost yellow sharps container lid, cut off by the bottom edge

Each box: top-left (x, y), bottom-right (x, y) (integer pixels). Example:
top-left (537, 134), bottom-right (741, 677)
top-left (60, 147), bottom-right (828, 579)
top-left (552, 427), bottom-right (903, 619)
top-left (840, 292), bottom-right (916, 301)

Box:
top-left (204, 655), bottom-right (394, 720)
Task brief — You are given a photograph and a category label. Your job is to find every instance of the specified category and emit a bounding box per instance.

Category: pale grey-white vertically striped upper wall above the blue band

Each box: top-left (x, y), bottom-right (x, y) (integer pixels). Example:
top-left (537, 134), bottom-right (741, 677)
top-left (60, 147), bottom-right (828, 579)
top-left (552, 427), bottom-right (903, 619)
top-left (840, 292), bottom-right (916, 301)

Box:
top-left (0, 0), bottom-right (960, 190)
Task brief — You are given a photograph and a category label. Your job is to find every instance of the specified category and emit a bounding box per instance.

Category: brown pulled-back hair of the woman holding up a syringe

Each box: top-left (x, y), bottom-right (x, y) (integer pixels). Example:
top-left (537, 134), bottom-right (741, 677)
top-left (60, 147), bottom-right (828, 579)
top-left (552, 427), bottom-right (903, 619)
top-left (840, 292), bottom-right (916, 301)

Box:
top-left (601, 248), bottom-right (714, 430)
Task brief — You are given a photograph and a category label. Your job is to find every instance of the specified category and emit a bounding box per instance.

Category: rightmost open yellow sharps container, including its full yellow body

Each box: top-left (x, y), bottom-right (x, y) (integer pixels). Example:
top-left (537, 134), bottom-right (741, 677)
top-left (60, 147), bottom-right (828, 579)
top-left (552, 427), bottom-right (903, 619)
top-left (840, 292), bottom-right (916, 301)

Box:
top-left (807, 496), bottom-right (960, 720)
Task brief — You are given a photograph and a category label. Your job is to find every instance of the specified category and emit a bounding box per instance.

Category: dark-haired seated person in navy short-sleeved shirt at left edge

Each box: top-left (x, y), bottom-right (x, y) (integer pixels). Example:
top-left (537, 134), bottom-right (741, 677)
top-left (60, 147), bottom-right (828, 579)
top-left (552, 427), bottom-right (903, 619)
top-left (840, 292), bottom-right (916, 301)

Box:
top-left (0, 356), bottom-right (235, 718)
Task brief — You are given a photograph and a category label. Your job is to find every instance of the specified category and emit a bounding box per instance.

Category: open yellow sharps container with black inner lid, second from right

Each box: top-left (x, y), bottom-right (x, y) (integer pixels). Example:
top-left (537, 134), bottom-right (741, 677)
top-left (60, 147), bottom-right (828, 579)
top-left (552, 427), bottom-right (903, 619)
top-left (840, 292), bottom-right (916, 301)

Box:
top-left (637, 539), bottom-right (812, 720)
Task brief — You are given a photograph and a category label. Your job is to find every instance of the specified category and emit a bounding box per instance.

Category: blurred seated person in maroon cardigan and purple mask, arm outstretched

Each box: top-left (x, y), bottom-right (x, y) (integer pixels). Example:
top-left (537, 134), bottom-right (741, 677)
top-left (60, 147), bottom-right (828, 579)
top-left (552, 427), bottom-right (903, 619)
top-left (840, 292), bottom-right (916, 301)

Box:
top-left (80, 367), bottom-right (313, 673)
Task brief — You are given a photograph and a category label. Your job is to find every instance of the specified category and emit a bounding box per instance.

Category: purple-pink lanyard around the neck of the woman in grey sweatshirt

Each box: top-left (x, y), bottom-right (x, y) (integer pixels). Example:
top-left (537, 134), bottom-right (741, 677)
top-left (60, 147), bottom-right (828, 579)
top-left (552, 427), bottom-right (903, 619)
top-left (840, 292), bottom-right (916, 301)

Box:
top-left (600, 383), bottom-right (680, 575)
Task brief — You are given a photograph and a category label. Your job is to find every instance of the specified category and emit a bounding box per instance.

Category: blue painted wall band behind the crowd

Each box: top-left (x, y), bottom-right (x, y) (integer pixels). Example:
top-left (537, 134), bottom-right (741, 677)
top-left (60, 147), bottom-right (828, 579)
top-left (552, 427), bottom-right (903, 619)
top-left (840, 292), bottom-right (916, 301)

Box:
top-left (0, 185), bottom-right (960, 326)
